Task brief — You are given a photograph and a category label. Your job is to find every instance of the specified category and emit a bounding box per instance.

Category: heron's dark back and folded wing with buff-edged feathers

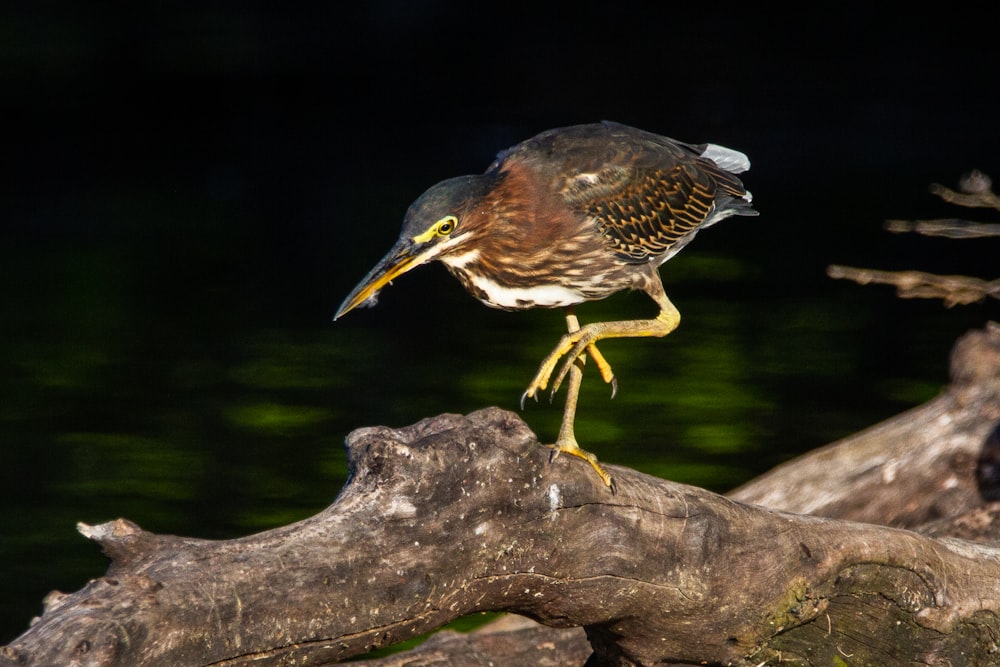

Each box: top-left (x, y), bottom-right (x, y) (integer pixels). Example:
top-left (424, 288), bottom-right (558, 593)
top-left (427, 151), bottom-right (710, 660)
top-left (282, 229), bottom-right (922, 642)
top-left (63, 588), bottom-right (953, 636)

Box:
top-left (489, 122), bottom-right (757, 265)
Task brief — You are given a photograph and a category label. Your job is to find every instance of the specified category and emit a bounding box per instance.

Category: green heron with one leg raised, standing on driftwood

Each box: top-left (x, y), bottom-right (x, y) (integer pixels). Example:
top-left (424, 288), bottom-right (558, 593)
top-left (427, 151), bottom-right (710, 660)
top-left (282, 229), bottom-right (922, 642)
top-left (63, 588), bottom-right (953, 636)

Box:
top-left (334, 122), bottom-right (757, 490)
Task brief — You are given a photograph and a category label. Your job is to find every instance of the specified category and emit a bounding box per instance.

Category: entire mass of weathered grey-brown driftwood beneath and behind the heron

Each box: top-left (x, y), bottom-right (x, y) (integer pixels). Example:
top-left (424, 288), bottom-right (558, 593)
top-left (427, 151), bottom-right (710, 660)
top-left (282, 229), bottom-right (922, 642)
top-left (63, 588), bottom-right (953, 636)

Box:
top-left (0, 325), bottom-right (1000, 666)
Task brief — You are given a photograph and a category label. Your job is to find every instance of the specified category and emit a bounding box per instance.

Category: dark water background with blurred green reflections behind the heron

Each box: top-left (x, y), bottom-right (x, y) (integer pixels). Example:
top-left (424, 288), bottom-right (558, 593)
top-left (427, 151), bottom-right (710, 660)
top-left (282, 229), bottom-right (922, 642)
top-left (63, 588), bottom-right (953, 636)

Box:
top-left (0, 1), bottom-right (1000, 640)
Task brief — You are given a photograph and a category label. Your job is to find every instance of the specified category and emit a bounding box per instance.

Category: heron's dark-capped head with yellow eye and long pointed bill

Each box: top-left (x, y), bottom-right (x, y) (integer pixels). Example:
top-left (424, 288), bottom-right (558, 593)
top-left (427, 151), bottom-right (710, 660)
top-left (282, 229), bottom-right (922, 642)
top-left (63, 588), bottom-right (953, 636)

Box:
top-left (333, 176), bottom-right (489, 320)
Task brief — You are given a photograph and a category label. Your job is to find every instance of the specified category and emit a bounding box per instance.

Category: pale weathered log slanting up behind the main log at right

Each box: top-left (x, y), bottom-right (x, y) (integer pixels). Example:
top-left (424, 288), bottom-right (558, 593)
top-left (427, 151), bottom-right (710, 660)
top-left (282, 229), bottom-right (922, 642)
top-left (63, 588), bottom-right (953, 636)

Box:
top-left (730, 323), bottom-right (1000, 539)
